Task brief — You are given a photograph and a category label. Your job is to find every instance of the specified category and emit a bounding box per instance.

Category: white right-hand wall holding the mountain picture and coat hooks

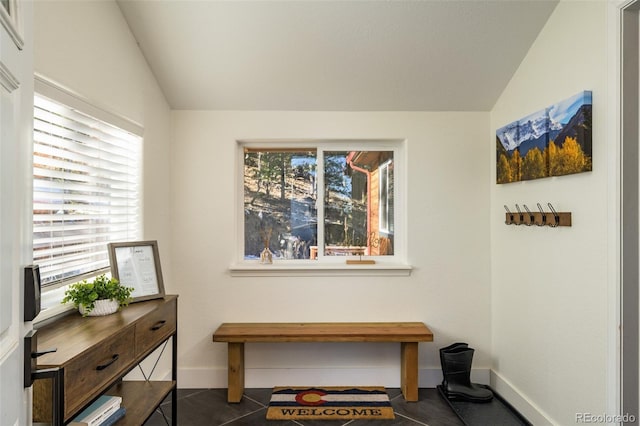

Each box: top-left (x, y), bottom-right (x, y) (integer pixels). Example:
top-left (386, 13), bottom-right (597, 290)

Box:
top-left (487, 1), bottom-right (608, 424)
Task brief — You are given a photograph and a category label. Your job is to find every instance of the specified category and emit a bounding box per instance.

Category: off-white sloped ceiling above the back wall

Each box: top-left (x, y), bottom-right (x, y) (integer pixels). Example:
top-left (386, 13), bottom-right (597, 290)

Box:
top-left (118, 0), bottom-right (557, 111)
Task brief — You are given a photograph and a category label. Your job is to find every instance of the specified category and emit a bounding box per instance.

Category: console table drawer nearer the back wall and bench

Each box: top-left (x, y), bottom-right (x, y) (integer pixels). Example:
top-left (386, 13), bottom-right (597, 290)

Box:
top-left (136, 299), bottom-right (177, 356)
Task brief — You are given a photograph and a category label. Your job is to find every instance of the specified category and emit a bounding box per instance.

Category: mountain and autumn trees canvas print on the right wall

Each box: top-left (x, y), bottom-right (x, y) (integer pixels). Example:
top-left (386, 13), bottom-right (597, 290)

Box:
top-left (496, 91), bottom-right (592, 183)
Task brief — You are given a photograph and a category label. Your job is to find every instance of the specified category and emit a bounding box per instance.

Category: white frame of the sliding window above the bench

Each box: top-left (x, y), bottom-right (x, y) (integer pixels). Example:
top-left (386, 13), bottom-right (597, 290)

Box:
top-left (229, 139), bottom-right (411, 276)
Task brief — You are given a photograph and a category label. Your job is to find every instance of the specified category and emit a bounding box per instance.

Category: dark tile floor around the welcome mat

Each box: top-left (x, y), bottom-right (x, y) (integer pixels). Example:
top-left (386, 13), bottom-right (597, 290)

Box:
top-left (145, 389), bottom-right (463, 426)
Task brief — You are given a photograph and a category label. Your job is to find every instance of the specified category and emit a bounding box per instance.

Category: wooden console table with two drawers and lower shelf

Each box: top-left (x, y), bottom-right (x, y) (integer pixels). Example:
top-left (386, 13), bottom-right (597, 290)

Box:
top-left (33, 296), bottom-right (178, 426)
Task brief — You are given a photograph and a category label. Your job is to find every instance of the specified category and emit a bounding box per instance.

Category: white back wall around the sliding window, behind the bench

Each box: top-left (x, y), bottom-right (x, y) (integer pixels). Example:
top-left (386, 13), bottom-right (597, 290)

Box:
top-left (171, 111), bottom-right (491, 387)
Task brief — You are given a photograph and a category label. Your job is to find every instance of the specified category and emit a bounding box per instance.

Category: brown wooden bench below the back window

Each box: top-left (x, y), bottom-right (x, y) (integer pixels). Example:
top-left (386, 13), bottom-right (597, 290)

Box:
top-left (213, 322), bottom-right (433, 402)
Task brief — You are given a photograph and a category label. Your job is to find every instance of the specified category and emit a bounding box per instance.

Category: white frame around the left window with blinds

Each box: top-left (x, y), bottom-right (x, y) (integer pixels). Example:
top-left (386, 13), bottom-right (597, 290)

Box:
top-left (34, 75), bottom-right (144, 322)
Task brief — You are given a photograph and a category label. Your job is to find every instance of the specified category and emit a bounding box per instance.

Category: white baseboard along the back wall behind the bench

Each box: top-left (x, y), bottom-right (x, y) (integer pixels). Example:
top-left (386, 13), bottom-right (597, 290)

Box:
top-left (178, 367), bottom-right (490, 389)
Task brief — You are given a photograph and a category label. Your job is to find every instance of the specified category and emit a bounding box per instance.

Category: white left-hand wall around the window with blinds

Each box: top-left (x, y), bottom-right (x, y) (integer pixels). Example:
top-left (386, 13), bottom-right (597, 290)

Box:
top-left (34, 0), bottom-right (174, 282)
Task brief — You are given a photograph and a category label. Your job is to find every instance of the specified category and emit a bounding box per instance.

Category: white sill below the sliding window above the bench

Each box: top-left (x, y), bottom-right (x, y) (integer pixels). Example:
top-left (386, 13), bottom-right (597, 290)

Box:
top-left (229, 262), bottom-right (413, 277)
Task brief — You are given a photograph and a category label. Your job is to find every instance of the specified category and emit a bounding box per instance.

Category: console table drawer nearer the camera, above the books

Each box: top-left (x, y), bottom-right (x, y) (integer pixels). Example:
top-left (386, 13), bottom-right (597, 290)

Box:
top-left (64, 327), bottom-right (135, 419)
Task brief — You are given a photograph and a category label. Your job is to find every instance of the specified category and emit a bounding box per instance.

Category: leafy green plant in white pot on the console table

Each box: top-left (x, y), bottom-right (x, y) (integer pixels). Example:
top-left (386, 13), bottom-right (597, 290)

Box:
top-left (62, 274), bottom-right (133, 317)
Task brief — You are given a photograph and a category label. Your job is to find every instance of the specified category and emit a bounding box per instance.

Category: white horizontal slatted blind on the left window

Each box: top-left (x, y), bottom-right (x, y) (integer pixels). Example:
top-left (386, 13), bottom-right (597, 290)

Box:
top-left (33, 95), bottom-right (142, 285)
